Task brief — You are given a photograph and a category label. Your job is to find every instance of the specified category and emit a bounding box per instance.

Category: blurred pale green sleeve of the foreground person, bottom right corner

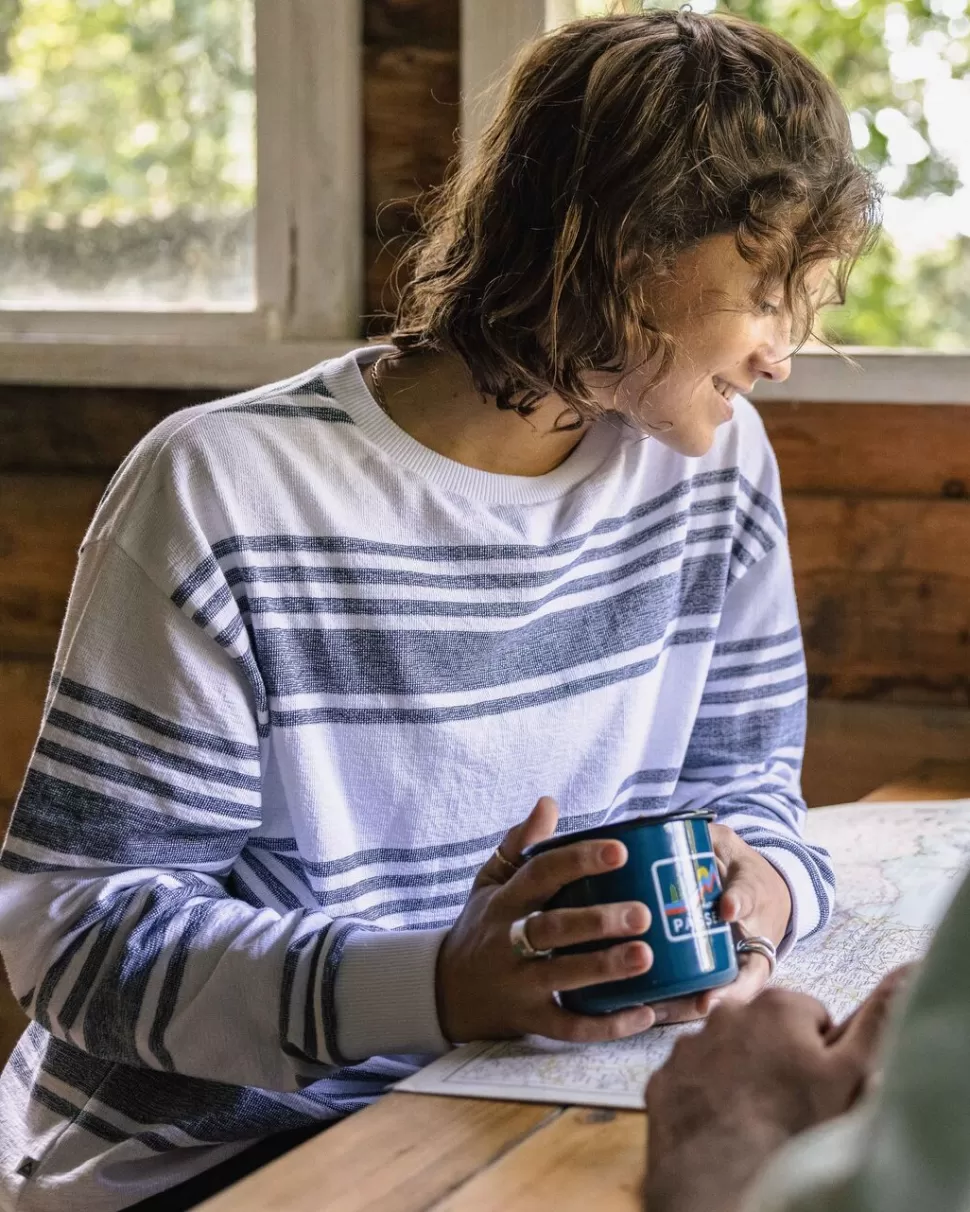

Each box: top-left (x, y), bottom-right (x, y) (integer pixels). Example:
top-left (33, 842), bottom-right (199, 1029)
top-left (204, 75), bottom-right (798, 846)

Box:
top-left (743, 879), bottom-right (970, 1212)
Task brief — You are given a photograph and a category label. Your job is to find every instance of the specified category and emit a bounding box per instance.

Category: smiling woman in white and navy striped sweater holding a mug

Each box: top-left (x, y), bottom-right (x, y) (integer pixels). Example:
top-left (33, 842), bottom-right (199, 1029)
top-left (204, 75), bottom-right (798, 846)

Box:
top-left (0, 12), bottom-right (875, 1212)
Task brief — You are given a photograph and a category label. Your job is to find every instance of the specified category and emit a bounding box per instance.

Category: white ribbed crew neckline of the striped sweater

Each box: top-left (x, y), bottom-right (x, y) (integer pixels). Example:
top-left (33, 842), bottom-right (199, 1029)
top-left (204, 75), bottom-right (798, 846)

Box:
top-left (324, 345), bottom-right (620, 505)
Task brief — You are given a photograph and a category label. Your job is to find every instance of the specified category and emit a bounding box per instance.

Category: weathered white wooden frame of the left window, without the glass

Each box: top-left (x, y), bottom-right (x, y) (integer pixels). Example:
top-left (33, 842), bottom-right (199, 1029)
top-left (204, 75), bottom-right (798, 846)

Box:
top-left (0, 0), bottom-right (364, 388)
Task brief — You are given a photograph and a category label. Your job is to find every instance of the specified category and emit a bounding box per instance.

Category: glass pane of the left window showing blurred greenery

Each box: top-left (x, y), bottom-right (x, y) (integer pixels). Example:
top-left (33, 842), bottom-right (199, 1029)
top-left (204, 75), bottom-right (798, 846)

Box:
top-left (0, 0), bottom-right (256, 310)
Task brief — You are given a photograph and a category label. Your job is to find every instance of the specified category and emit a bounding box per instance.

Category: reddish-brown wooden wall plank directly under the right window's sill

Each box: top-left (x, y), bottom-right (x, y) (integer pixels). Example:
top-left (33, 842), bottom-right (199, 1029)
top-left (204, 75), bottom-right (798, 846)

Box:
top-left (754, 396), bottom-right (970, 499)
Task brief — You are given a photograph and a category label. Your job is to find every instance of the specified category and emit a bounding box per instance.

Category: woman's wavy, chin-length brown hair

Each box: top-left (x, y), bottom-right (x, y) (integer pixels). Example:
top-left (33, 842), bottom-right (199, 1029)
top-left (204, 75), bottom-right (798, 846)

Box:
top-left (390, 10), bottom-right (879, 424)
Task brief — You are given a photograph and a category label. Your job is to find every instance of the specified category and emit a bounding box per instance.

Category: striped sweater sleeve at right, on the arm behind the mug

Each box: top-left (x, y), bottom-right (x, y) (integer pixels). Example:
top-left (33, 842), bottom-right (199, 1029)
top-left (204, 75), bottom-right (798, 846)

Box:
top-left (672, 460), bottom-right (834, 954)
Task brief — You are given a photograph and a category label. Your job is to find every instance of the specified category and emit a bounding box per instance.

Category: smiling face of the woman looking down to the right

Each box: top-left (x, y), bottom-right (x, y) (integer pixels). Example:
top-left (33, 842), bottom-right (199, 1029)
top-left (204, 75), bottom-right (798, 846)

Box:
top-left (589, 235), bottom-right (829, 456)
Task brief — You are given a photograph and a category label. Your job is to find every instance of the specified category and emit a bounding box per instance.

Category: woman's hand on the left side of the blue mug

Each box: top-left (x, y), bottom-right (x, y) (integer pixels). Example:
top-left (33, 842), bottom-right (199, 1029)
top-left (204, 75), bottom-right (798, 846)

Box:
top-left (437, 796), bottom-right (654, 1044)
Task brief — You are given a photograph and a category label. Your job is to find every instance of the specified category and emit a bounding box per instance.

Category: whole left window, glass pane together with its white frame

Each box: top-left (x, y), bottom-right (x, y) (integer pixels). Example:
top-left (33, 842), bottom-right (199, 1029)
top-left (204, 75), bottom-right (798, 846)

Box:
top-left (0, 0), bottom-right (363, 382)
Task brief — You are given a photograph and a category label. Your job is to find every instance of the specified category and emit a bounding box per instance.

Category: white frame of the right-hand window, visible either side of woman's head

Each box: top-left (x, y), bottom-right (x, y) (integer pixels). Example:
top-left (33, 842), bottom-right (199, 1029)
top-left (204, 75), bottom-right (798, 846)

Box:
top-left (461, 0), bottom-right (970, 404)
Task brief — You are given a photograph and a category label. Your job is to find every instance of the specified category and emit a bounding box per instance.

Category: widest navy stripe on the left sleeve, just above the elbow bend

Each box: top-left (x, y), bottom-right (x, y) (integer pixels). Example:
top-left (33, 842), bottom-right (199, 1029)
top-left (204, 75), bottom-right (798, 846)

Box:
top-left (6, 770), bottom-right (252, 868)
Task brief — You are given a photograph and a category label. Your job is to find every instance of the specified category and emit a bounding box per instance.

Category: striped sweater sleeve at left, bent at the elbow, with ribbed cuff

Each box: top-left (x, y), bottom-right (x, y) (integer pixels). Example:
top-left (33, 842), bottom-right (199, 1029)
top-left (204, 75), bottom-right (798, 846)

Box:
top-left (0, 538), bottom-right (443, 1091)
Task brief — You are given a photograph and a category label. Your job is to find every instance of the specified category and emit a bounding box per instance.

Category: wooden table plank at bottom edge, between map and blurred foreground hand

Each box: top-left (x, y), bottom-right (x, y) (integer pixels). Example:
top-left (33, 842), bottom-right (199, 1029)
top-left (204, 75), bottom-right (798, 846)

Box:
top-left (429, 1110), bottom-right (646, 1212)
